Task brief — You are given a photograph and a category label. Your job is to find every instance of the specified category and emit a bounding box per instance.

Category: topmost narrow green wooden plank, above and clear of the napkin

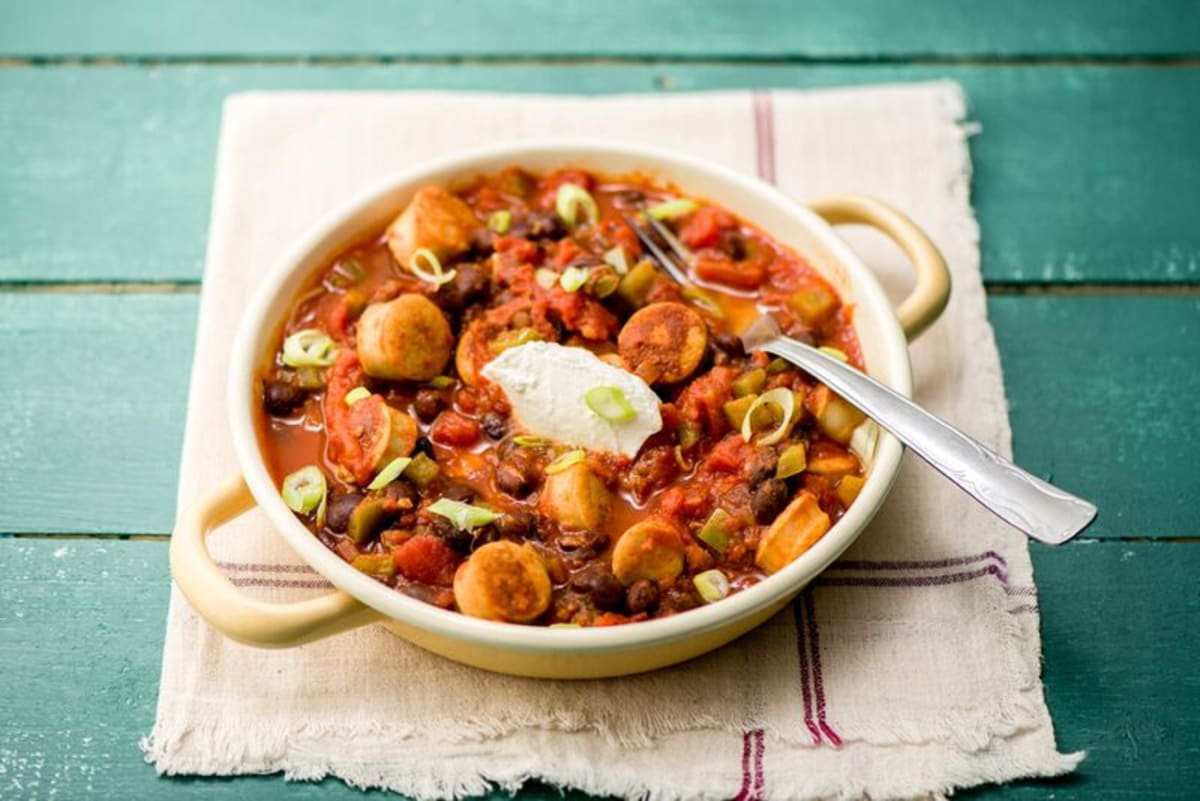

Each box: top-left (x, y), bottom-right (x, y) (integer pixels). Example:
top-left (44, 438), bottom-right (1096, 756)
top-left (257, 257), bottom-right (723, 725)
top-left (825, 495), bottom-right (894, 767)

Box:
top-left (0, 0), bottom-right (1200, 59)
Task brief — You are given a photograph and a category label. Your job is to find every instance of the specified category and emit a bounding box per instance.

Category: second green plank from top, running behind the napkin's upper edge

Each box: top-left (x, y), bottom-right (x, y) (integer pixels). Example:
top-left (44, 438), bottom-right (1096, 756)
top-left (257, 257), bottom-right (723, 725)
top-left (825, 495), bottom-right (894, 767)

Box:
top-left (0, 65), bottom-right (1200, 283)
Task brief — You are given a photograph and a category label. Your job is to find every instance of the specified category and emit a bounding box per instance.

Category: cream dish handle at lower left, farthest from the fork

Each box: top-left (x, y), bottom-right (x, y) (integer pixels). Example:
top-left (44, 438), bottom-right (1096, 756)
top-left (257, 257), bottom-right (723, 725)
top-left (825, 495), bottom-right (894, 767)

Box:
top-left (170, 476), bottom-right (382, 648)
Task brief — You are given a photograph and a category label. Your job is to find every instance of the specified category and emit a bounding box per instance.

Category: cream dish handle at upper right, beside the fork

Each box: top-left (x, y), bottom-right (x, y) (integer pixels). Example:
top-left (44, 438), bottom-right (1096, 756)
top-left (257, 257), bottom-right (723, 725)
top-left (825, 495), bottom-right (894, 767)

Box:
top-left (805, 194), bottom-right (950, 342)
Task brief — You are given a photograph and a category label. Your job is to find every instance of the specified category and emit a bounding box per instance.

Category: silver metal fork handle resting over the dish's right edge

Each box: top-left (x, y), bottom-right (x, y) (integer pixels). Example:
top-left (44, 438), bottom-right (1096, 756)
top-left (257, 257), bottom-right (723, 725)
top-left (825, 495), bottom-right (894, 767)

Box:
top-left (746, 326), bottom-right (1096, 546)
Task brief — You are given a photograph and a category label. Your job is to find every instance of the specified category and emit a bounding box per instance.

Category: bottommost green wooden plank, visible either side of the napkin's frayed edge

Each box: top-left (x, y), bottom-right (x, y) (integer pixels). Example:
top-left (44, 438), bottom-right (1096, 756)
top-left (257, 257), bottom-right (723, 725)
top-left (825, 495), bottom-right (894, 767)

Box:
top-left (0, 538), bottom-right (1200, 801)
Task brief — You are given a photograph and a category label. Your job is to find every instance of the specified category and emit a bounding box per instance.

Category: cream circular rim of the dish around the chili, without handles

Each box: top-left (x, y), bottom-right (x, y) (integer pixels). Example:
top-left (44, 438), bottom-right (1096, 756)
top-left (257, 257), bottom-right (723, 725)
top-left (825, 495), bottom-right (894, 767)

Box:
top-left (227, 138), bottom-right (912, 654)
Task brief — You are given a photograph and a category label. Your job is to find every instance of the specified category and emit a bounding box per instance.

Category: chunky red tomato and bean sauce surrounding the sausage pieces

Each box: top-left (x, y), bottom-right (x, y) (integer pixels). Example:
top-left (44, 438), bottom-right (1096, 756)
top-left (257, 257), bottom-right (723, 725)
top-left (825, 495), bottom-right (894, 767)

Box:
top-left (259, 168), bottom-right (862, 625)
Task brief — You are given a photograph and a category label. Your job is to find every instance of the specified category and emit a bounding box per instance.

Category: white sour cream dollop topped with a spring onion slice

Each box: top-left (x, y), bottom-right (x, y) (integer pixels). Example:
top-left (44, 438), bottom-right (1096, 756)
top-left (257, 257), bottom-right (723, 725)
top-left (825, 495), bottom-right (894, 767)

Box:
top-left (481, 342), bottom-right (662, 458)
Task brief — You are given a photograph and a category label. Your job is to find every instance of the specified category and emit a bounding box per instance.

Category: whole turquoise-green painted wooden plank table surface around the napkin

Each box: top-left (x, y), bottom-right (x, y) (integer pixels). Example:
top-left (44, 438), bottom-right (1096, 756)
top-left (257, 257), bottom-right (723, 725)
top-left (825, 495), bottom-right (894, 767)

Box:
top-left (0, 0), bottom-right (1200, 800)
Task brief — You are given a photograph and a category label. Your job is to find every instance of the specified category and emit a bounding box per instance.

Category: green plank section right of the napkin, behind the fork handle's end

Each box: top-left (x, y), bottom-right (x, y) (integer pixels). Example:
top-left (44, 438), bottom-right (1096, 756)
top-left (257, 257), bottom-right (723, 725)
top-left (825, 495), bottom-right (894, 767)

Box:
top-left (989, 295), bottom-right (1200, 537)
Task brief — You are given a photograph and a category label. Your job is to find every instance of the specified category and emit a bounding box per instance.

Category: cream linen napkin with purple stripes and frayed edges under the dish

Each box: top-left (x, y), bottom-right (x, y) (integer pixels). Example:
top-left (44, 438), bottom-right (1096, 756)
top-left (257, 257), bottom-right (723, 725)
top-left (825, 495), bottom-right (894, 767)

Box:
top-left (143, 83), bottom-right (1080, 800)
